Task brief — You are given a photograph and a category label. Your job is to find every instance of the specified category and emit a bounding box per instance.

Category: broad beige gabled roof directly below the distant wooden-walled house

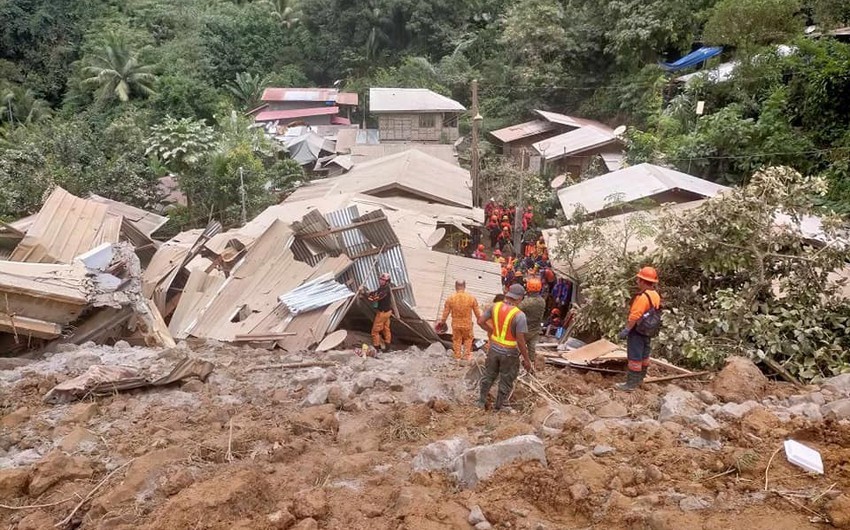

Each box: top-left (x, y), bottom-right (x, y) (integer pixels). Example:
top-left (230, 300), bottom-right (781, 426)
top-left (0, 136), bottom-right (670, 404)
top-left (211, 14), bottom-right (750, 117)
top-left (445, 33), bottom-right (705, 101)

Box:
top-left (284, 149), bottom-right (472, 208)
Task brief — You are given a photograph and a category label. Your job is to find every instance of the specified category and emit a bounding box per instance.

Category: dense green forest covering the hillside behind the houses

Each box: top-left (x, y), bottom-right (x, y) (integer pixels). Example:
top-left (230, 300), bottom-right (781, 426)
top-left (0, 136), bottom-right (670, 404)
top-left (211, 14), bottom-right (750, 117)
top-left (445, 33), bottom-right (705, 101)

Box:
top-left (0, 0), bottom-right (850, 229)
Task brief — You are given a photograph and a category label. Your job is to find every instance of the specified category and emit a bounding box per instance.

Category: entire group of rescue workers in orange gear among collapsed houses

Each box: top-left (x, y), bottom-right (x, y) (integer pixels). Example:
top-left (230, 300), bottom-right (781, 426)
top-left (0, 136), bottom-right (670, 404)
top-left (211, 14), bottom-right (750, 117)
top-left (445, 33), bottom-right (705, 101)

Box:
top-left (364, 203), bottom-right (661, 411)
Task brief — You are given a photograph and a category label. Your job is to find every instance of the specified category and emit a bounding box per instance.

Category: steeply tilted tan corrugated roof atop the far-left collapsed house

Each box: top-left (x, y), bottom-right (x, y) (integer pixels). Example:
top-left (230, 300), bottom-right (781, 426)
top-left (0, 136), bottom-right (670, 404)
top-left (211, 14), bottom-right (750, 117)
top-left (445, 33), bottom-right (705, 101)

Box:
top-left (9, 187), bottom-right (121, 263)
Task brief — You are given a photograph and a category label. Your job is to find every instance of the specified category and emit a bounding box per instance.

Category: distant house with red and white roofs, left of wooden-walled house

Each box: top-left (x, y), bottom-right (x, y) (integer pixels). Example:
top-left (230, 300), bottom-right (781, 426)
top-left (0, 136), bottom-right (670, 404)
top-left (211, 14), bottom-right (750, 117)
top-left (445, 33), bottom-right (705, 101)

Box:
top-left (251, 88), bottom-right (358, 126)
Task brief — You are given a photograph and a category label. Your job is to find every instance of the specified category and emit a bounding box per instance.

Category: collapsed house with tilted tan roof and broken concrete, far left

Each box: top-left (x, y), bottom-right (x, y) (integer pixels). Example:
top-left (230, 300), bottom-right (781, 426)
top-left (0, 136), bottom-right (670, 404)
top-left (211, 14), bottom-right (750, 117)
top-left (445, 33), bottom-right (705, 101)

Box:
top-left (0, 188), bottom-right (173, 353)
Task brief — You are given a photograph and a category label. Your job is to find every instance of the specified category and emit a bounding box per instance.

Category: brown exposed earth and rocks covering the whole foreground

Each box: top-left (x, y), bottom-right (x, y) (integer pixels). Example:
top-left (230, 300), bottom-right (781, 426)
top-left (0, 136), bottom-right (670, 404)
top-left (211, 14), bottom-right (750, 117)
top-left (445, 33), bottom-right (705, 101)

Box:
top-left (0, 343), bottom-right (850, 530)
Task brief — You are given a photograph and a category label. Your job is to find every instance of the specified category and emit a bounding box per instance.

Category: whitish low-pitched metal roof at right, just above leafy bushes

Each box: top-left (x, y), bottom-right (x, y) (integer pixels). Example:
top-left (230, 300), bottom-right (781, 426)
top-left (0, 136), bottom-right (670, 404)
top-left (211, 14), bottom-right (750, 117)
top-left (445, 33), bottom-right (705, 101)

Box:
top-left (558, 164), bottom-right (728, 218)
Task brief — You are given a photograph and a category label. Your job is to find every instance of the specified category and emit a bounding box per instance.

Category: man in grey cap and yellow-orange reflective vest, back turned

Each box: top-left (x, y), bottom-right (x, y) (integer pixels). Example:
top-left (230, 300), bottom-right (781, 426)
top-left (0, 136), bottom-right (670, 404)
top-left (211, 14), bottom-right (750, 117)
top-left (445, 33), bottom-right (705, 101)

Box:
top-left (478, 285), bottom-right (533, 410)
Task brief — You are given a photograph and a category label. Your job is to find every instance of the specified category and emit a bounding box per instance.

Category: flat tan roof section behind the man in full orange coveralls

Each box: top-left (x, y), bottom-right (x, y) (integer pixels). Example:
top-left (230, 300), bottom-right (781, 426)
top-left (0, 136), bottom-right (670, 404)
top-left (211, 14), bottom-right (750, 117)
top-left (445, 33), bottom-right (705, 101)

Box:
top-left (404, 248), bottom-right (502, 338)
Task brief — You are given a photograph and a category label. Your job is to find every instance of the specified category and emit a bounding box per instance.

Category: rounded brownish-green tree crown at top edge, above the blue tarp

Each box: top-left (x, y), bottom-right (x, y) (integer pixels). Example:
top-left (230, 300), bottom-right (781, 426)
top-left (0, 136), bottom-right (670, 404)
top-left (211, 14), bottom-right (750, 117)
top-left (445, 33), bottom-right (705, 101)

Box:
top-left (704, 0), bottom-right (803, 48)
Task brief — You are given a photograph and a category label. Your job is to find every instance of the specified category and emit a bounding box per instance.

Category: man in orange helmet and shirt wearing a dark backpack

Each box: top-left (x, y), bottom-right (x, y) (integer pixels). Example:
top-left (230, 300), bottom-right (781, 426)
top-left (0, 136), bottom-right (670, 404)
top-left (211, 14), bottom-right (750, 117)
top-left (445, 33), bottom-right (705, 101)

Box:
top-left (616, 267), bottom-right (661, 392)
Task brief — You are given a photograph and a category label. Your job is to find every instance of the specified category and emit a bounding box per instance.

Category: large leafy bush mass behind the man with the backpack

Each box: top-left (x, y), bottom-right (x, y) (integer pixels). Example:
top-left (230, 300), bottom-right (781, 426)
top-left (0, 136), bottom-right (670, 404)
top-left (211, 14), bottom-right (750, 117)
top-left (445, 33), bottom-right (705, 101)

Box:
top-left (557, 167), bottom-right (850, 380)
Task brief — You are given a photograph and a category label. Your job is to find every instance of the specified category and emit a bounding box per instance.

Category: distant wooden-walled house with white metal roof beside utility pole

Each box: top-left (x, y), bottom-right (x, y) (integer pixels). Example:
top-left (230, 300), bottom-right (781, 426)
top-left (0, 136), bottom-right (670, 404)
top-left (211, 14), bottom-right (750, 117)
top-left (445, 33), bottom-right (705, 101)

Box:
top-left (369, 88), bottom-right (466, 143)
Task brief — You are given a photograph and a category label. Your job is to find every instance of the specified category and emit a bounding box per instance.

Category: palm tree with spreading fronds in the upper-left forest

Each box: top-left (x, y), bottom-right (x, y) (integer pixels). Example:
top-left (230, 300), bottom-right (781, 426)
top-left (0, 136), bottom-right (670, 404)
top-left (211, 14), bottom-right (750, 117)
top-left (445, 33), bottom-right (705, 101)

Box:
top-left (83, 34), bottom-right (156, 102)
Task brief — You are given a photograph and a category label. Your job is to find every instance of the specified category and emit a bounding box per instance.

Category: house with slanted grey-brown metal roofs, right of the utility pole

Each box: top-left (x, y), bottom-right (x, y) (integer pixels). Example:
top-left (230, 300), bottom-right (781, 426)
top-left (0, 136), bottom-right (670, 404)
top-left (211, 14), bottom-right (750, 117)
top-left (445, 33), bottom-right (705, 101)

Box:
top-left (490, 110), bottom-right (623, 177)
